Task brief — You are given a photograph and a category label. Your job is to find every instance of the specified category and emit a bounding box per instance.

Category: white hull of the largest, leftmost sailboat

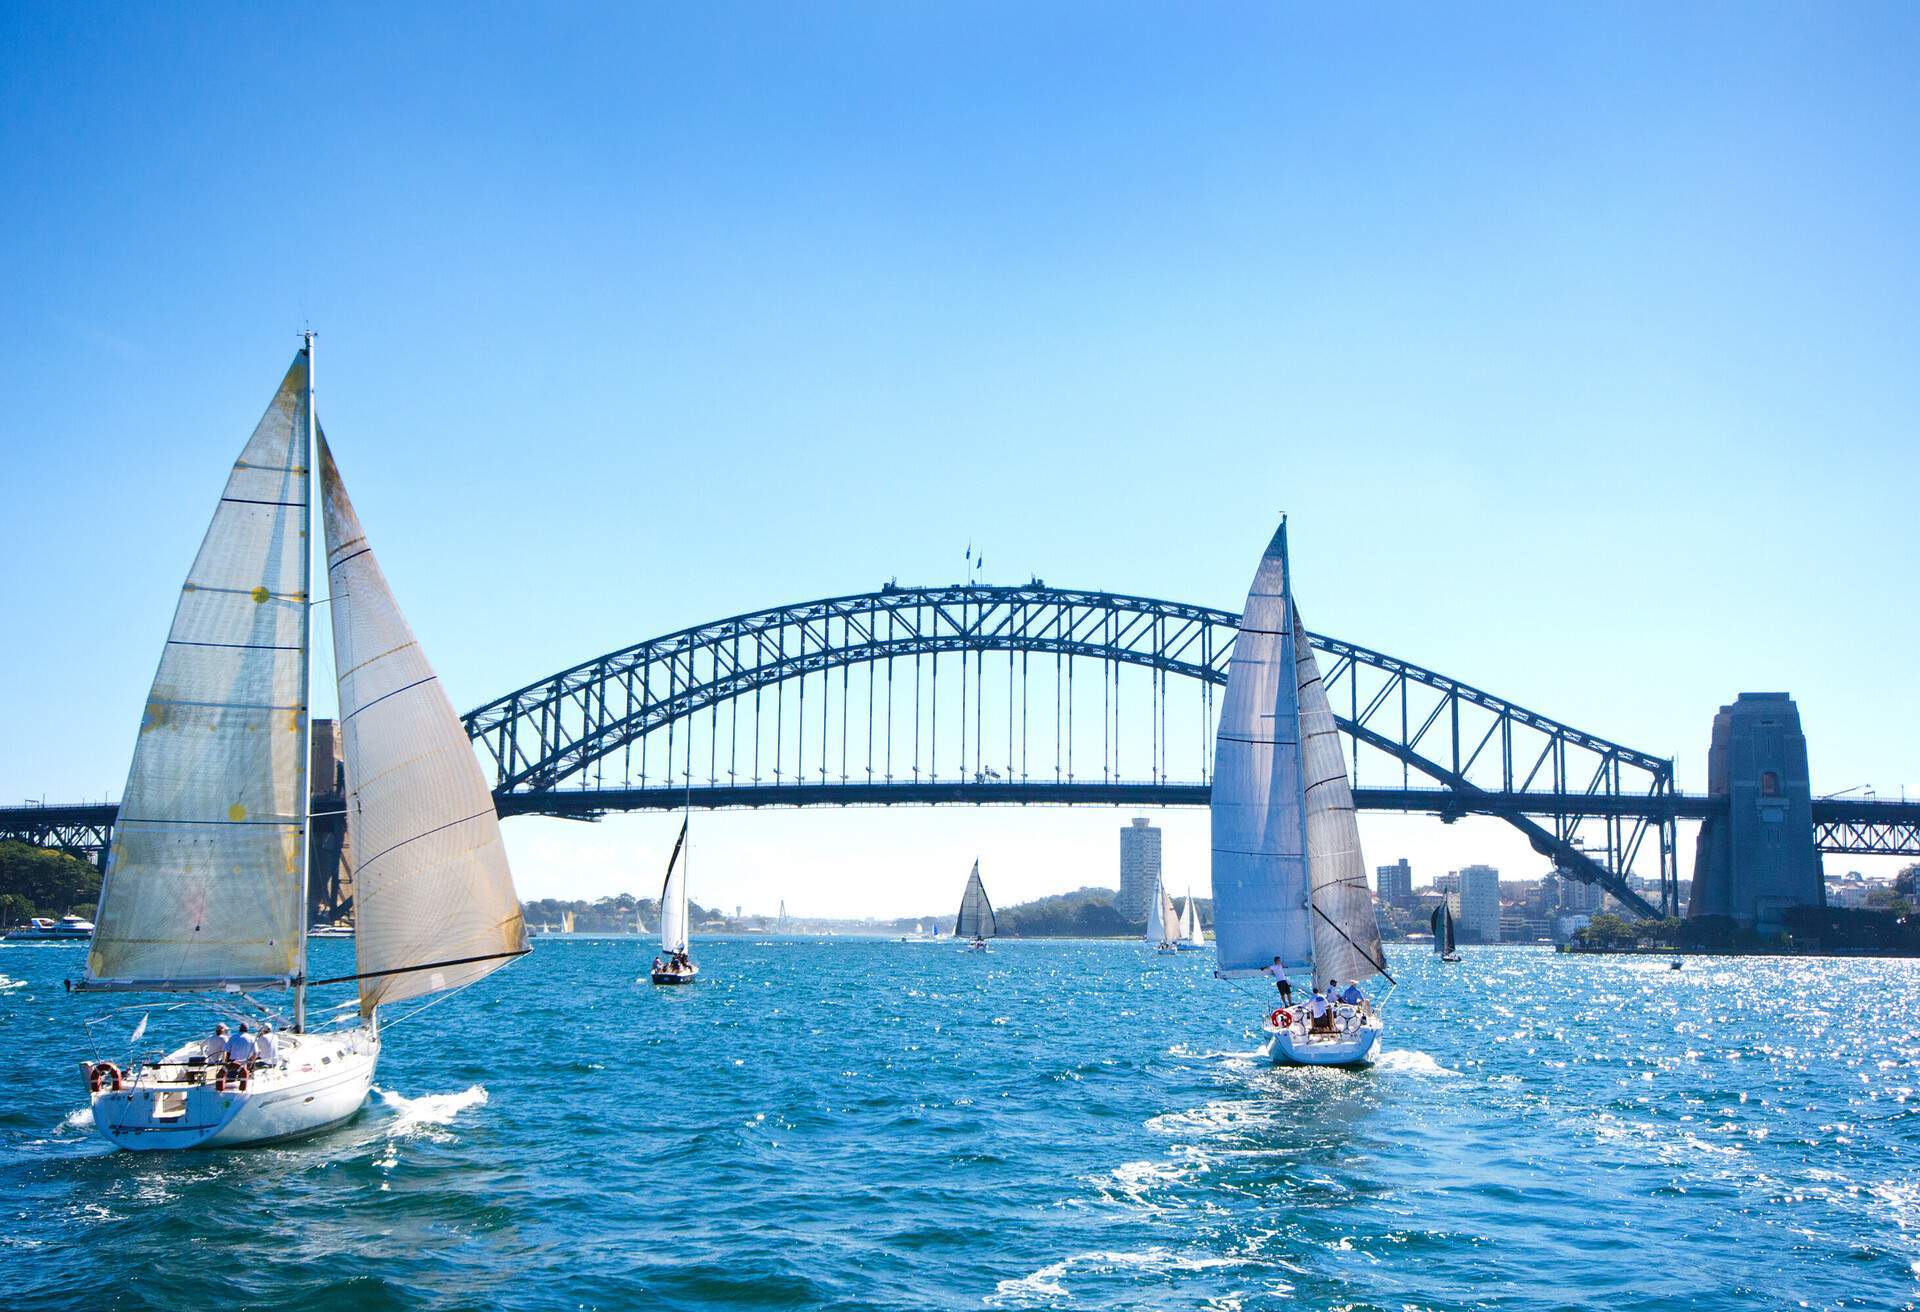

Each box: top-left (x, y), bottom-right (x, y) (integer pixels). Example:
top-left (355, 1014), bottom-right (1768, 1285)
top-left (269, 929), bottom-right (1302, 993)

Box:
top-left (94, 1028), bottom-right (380, 1151)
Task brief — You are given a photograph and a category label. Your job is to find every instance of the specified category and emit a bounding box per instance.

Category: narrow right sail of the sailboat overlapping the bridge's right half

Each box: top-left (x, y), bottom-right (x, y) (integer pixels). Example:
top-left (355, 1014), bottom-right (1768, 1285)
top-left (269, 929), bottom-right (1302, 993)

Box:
top-left (1294, 607), bottom-right (1386, 984)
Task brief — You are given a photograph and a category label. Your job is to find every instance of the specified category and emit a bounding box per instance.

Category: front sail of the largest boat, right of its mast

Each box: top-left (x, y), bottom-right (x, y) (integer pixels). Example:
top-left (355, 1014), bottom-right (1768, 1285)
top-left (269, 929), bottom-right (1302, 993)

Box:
top-left (319, 436), bottom-right (526, 1014)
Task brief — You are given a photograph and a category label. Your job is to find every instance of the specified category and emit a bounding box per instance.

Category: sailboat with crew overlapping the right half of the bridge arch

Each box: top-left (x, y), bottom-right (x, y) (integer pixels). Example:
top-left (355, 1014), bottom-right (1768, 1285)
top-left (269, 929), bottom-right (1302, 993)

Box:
top-left (1212, 519), bottom-right (1392, 1066)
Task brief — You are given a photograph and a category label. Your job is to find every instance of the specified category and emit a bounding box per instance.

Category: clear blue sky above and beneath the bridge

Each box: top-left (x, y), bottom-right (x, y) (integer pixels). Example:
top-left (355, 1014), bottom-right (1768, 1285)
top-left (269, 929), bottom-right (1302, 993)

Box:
top-left (0, 4), bottom-right (1920, 912)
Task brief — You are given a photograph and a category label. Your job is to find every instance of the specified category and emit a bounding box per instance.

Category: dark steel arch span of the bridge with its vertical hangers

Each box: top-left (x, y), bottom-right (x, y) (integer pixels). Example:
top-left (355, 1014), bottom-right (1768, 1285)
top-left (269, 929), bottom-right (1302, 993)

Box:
top-left (465, 580), bottom-right (1682, 914)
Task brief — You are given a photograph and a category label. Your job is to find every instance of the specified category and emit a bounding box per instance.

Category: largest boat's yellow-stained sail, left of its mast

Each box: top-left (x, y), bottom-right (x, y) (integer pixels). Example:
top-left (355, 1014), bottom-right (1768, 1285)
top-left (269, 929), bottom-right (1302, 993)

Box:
top-left (86, 350), bottom-right (311, 989)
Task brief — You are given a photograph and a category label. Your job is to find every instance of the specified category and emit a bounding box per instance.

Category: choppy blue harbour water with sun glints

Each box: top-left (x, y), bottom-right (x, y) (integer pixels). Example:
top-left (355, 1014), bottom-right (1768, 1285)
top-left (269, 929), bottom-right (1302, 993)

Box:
top-left (0, 939), bottom-right (1920, 1312)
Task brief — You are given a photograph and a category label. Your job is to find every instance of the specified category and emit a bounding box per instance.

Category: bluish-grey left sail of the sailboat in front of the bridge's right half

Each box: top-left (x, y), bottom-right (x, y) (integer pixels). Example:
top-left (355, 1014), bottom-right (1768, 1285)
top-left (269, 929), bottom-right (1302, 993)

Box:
top-left (1212, 521), bottom-right (1313, 976)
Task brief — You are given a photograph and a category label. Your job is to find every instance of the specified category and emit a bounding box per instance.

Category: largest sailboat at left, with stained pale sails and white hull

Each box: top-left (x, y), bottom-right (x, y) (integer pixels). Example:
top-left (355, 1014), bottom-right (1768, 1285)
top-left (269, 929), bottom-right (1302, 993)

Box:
top-left (73, 334), bottom-right (528, 1149)
